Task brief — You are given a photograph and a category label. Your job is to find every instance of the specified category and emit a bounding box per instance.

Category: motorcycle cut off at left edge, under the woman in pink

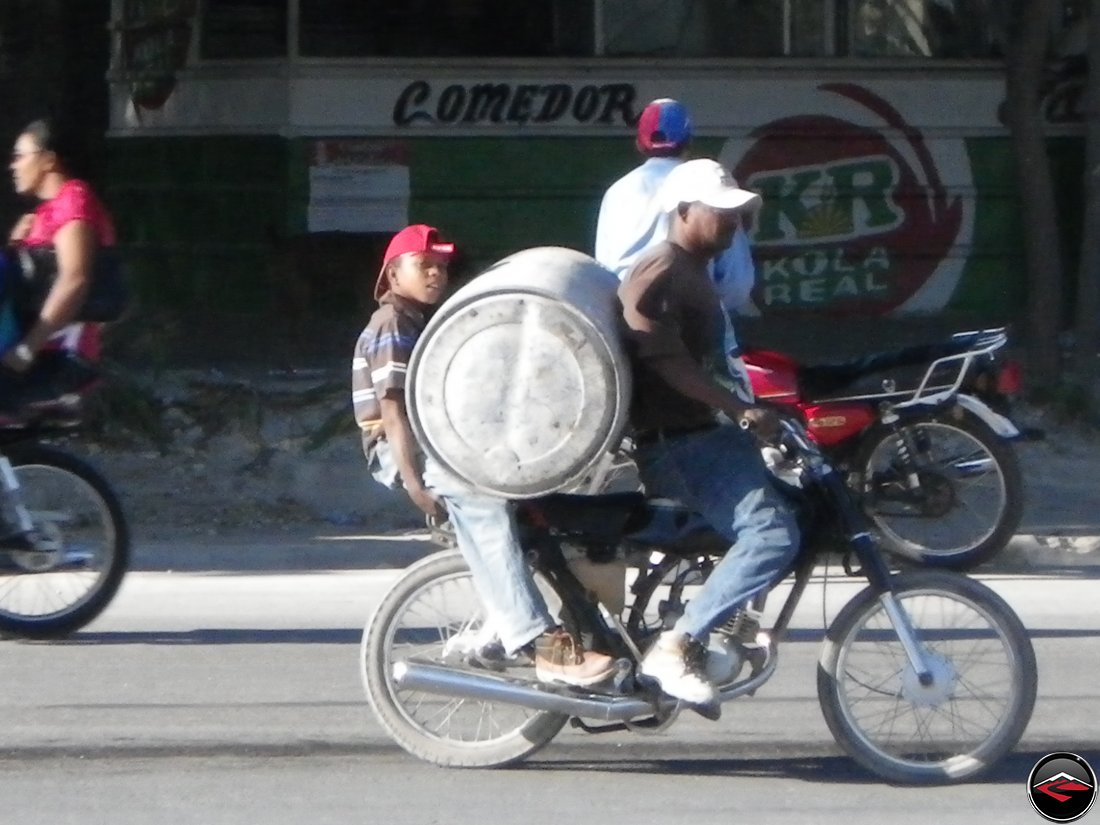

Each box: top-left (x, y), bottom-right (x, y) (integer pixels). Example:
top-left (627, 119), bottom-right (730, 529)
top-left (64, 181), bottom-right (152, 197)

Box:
top-left (0, 356), bottom-right (130, 639)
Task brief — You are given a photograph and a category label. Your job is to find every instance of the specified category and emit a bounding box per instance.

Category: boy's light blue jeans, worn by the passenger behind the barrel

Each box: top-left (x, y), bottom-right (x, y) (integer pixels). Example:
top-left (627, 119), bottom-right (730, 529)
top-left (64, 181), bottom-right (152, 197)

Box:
top-left (370, 440), bottom-right (556, 653)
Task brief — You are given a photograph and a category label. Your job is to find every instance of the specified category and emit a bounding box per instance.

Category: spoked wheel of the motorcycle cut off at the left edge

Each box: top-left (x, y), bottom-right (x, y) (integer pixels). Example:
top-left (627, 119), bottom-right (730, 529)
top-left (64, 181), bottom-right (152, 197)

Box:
top-left (0, 444), bottom-right (130, 639)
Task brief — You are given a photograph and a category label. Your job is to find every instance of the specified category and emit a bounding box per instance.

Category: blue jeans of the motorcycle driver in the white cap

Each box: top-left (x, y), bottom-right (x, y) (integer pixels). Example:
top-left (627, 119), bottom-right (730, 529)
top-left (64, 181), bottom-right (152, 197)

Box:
top-left (636, 426), bottom-right (799, 644)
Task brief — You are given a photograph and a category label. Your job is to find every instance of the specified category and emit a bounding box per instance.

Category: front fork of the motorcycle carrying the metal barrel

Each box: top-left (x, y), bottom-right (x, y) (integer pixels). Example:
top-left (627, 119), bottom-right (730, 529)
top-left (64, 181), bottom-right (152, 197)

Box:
top-left (821, 468), bottom-right (933, 686)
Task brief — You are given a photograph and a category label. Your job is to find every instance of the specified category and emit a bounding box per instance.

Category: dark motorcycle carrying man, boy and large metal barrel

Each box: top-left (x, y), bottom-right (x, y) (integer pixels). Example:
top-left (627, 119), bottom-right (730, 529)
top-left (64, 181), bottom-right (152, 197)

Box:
top-left (360, 420), bottom-right (1037, 784)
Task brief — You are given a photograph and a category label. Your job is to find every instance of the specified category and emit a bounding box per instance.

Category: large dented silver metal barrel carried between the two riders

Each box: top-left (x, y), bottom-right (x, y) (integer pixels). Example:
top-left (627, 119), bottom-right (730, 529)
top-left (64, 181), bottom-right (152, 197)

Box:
top-left (407, 246), bottom-right (630, 498)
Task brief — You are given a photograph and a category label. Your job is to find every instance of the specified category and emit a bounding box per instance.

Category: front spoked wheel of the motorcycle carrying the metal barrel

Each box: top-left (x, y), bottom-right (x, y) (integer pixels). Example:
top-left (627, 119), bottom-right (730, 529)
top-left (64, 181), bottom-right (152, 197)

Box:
top-left (817, 571), bottom-right (1038, 784)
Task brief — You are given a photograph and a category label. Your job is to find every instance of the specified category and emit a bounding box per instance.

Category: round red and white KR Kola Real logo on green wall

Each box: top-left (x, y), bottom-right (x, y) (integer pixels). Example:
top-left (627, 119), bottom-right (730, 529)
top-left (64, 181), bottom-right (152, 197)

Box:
top-left (722, 84), bottom-right (974, 315)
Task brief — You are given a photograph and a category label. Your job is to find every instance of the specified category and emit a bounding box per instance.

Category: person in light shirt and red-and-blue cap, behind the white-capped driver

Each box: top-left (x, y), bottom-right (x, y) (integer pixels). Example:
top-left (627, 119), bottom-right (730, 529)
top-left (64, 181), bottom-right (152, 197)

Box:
top-left (595, 98), bottom-right (756, 403)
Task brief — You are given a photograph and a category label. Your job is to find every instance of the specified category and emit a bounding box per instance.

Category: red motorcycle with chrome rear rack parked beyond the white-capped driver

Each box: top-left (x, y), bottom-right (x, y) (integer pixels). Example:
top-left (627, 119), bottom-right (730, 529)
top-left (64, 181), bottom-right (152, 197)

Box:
top-left (743, 329), bottom-right (1041, 570)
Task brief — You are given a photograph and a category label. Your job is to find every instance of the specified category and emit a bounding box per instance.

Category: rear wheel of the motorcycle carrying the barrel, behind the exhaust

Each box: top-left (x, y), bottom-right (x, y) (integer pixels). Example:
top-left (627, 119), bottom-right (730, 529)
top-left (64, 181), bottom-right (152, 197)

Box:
top-left (360, 550), bottom-right (568, 768)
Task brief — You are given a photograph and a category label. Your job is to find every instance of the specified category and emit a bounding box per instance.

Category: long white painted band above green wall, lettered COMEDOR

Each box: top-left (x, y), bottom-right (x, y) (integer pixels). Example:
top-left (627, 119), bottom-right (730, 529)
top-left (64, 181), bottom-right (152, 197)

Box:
top-left (112, 66), bottom-right (1020, 138)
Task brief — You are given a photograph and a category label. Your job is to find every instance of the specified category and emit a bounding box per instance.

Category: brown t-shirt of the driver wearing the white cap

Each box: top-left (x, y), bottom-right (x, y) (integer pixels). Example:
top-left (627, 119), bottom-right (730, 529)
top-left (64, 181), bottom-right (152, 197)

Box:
top-left (618, 241), bottom-right (725, 432)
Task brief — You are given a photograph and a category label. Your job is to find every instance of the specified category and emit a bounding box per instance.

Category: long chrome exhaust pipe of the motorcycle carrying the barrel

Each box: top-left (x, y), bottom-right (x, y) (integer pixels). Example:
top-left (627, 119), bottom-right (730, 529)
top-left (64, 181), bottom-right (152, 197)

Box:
top-left (393, 661), bottom-right (675, 722)
